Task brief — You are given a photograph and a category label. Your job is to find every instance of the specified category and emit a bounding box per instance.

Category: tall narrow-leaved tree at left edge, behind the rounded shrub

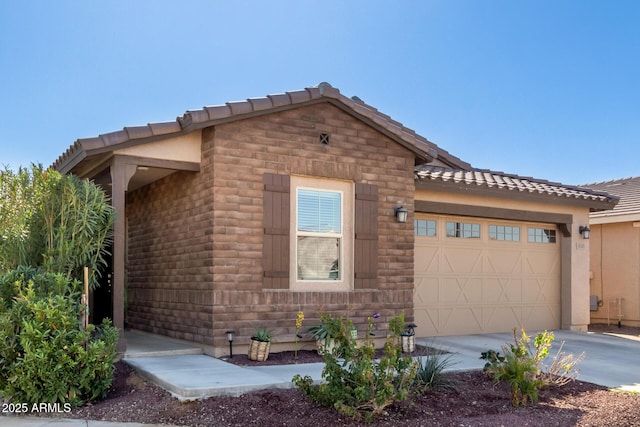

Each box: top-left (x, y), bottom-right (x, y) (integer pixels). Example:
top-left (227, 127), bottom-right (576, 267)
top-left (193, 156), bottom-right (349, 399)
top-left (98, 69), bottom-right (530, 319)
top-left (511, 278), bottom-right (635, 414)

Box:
top-left (0, 165), bottom-right (115, 289)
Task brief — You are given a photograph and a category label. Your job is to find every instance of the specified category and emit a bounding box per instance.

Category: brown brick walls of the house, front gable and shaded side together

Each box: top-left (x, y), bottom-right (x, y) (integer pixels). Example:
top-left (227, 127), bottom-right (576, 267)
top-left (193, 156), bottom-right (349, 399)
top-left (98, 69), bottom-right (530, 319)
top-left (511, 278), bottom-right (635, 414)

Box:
top-left (127, 102), bottom-right (415, 349)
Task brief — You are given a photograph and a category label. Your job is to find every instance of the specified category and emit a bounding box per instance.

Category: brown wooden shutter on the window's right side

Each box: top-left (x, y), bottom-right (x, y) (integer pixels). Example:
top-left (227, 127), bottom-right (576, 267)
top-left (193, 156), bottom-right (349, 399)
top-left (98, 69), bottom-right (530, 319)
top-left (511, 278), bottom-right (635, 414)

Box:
top-left (353, 184), bottom-right (378, 289)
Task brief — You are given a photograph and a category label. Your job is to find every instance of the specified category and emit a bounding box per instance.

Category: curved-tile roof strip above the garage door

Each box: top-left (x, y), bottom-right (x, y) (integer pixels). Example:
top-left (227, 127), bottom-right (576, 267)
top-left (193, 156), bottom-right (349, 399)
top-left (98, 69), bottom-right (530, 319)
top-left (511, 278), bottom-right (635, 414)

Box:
top-left (415, 165), bottom-right (617, 209)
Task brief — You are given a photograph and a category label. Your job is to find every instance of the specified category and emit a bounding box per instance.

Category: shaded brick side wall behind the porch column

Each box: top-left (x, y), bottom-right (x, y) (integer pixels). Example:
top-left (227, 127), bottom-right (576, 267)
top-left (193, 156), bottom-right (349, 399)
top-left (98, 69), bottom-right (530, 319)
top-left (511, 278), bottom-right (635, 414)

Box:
top-left (125, 167), bottom-right (213, 345)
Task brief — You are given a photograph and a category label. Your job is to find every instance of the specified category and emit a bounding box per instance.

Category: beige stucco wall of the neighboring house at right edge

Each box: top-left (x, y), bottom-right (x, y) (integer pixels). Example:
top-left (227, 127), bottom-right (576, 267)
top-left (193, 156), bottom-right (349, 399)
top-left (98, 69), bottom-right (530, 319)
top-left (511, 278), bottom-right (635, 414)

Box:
top-left (589, 219), bottom-right (640, 326)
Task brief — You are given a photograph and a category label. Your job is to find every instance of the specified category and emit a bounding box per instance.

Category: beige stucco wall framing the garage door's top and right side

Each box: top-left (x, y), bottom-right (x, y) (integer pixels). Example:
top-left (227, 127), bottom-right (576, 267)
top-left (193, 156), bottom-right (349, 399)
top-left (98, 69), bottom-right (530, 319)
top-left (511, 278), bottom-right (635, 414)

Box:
top-left (415, 189), bottom-right (590, 331)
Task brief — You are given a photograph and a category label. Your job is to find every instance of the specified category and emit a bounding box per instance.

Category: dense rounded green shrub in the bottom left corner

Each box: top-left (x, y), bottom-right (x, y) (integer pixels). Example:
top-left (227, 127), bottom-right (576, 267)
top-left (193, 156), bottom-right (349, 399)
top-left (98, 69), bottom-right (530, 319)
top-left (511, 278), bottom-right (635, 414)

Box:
top-left (0, 275), bottom-right (118, 406)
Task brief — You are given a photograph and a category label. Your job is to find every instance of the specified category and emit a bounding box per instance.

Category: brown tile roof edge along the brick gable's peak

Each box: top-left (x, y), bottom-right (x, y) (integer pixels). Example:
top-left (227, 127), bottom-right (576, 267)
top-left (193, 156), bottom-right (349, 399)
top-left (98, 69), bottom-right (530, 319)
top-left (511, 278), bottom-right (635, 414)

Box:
top-left (52, 82), bottom-right (471, 171)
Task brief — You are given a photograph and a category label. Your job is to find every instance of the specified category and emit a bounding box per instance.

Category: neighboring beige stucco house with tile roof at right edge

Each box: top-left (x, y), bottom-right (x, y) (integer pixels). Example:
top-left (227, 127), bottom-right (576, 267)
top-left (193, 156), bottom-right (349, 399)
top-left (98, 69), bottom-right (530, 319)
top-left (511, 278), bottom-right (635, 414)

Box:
top-left (586, 177), bottom-right (640, 326)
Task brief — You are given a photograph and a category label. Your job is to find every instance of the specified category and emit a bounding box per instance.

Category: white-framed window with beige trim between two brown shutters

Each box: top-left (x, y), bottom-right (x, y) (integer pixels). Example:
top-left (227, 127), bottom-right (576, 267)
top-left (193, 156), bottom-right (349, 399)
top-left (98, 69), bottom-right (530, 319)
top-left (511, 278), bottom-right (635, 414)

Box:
top-left (290, 177), bottom-right (353, 291)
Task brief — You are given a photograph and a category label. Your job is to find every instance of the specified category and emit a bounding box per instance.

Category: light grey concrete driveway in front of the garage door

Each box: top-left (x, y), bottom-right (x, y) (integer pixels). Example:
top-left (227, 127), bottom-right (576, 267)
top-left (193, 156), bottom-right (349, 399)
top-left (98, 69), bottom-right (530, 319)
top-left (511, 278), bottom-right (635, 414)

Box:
top-left (424, 331), bottom-right (640, 392)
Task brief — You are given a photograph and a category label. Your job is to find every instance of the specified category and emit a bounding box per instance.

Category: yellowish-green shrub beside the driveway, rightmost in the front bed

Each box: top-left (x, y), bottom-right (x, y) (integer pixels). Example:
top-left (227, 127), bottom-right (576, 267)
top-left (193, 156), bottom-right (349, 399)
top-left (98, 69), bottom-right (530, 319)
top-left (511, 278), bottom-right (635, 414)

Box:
top-left (480, 329), bottom-right (584, 406)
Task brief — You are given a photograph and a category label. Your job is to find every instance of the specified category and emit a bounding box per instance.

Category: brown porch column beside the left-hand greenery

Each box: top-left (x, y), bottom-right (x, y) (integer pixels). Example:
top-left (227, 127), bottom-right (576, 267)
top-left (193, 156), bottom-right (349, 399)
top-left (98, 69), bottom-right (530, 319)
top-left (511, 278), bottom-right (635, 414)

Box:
top-left (111, 156), bottom-right (136, 353)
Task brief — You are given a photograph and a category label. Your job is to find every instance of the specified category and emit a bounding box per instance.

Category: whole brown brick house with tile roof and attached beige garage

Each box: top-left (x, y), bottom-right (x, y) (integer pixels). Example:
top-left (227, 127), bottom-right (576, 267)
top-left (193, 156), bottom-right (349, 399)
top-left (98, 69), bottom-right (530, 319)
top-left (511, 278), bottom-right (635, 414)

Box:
top-left (54, 83), bottom-right (616, 355)
